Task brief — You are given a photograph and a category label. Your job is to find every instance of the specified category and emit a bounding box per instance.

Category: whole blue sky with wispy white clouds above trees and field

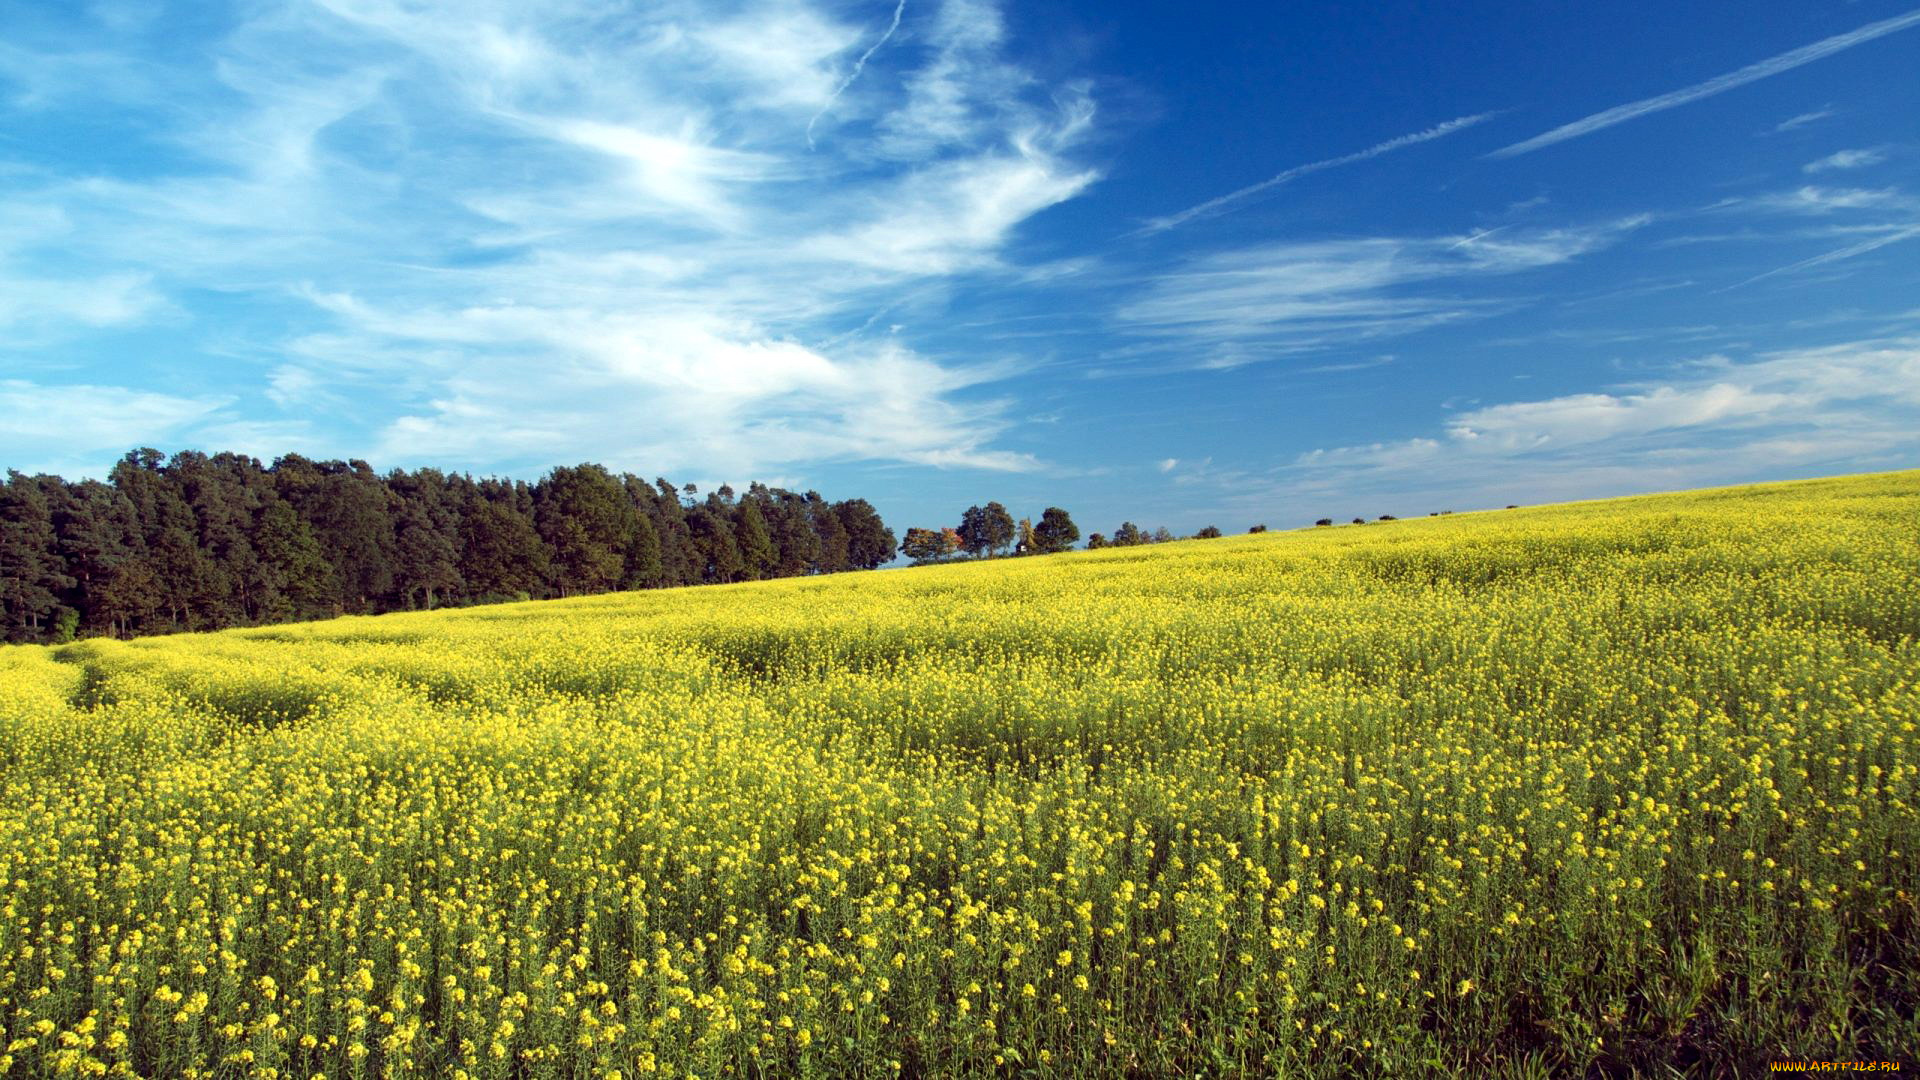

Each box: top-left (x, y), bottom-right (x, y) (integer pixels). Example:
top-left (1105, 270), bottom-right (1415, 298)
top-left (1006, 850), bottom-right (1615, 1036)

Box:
top-left (0, 0), bottom-right (1920, 532)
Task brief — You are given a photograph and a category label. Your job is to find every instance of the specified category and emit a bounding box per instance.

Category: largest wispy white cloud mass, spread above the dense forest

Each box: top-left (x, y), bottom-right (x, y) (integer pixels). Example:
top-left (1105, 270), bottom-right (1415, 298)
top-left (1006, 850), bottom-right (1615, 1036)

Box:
top-left (0, 0), bottom-right (1098, 477)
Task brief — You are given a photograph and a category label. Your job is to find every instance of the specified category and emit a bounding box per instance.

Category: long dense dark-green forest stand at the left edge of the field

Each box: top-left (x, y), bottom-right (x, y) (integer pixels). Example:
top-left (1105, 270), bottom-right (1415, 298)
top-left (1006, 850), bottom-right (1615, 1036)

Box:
top-left (0, 448), bottom-right (895, 642)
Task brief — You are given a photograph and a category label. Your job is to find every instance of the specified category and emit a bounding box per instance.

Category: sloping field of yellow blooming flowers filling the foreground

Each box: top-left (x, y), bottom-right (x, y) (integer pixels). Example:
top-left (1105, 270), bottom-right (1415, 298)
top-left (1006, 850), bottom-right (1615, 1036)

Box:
top-left (0, 473), bottom-right (1920, 1078)
